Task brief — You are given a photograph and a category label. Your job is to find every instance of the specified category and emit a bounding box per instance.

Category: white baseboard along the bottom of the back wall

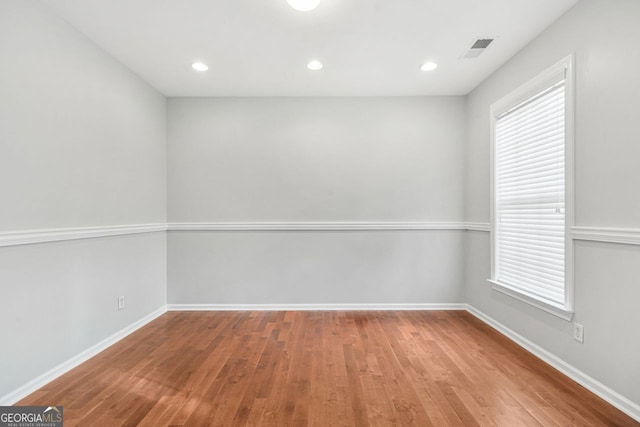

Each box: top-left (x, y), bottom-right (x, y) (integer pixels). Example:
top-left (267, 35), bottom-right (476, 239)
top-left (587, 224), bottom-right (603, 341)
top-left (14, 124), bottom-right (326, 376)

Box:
top-left (167, 303), bottom-right (467, 311)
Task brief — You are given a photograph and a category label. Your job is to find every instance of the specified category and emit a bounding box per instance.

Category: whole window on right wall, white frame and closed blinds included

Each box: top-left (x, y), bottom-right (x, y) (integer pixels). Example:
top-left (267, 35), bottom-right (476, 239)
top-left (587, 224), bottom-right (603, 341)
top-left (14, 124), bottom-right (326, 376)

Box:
top-left (490, 57), bottom-right (573, 320)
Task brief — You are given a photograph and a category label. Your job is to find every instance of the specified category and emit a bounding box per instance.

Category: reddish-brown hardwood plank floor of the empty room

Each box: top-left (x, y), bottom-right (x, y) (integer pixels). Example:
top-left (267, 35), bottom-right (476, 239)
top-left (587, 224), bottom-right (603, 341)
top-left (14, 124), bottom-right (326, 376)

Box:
top-left (19, 311), bottom-right (640, 427)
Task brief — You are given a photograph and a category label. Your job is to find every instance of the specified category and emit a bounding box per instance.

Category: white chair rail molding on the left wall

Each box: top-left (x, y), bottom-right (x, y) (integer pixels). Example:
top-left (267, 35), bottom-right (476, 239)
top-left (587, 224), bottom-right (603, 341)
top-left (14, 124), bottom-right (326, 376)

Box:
top-left (0, 224), bottom-right (167, 247)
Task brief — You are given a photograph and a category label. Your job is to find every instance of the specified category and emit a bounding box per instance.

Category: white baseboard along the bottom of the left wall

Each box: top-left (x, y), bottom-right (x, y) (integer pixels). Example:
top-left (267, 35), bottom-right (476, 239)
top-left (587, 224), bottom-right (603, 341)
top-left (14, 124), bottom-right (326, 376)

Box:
top-left (0, 306), bottom-right (167, 406)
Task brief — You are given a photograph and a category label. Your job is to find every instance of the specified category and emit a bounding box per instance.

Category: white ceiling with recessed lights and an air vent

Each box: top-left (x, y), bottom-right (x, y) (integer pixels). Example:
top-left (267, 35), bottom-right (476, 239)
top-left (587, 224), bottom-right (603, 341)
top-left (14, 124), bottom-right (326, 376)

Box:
top-left (42, 0), bottom-right (577, 96)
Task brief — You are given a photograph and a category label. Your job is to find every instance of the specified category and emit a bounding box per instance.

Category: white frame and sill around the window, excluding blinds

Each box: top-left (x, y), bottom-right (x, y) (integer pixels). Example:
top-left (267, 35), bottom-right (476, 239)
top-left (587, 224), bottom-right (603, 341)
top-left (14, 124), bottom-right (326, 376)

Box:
top-left (488, 54), bottom-right (575, 321)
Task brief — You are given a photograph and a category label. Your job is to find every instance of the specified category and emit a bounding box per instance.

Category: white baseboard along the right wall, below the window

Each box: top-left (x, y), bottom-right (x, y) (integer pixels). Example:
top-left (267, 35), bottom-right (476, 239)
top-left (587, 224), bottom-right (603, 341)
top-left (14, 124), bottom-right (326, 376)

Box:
top-left (467, 305), bottom-right (640, 421)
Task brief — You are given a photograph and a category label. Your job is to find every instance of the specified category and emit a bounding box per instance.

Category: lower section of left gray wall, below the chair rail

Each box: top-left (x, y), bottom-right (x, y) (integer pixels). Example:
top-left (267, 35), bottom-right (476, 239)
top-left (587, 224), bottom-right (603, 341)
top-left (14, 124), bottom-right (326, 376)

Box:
top-left (0, 233), bottom-right (166, 398)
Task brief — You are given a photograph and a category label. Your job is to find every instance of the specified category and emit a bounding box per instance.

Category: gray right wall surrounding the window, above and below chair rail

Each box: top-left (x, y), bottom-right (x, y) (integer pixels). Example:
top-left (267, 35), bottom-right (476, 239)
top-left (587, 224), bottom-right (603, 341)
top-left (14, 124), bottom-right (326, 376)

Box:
top-left (466, 0), bottom-right (640, 403)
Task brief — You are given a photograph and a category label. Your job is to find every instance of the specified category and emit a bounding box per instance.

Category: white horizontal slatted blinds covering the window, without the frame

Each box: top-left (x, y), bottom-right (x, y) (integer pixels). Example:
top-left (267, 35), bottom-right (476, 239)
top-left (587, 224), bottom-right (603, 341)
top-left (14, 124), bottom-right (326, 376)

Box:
top-left (494, 72), bottom-right (565, 307)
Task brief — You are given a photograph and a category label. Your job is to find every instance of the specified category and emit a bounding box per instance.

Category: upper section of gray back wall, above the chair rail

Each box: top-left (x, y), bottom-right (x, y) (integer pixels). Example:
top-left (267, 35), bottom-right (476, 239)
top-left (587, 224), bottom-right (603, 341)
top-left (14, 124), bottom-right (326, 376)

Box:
top-left (168, 97), bottom-right (464, 222)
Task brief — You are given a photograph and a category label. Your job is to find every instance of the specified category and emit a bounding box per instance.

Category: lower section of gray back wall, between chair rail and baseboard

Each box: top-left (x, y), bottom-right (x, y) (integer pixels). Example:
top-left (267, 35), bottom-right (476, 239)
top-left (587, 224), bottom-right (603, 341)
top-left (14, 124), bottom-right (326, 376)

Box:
top-left (168, 230), bottom-right (465, 305)
